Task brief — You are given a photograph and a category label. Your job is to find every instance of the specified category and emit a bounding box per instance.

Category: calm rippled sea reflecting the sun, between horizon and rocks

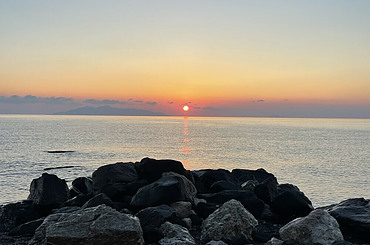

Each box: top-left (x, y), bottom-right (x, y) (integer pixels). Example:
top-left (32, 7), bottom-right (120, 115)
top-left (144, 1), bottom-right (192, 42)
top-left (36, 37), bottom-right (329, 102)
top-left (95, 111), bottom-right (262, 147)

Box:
top-left (0, 115), bottom-right (370, 207)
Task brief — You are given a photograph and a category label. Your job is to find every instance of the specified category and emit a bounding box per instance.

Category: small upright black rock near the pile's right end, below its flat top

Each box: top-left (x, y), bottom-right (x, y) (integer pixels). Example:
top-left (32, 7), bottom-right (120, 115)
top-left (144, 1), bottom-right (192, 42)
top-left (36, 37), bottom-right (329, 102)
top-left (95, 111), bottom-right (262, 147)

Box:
top-left (254, 177), bottom-right (278, 205)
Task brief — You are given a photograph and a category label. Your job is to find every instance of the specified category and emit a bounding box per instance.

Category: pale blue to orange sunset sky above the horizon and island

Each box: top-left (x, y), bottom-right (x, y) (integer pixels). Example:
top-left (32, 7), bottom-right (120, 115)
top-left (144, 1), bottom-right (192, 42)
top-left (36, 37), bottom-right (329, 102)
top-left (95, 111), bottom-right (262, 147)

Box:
top-left (0, 0), bottom-right (370, 118)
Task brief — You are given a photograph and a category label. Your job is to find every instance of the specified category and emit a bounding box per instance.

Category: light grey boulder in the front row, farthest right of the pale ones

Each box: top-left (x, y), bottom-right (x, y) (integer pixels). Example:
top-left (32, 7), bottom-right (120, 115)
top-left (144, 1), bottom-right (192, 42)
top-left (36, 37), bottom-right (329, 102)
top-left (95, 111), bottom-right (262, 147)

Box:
top-left (279, 209), bottom-right (343, 245)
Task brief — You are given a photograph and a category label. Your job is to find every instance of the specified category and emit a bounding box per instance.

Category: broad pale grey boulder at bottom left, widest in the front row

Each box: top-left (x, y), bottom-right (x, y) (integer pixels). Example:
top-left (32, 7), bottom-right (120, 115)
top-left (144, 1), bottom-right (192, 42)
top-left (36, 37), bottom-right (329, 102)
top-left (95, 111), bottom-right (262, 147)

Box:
top-left (30, 205), bottom-right (144, 245)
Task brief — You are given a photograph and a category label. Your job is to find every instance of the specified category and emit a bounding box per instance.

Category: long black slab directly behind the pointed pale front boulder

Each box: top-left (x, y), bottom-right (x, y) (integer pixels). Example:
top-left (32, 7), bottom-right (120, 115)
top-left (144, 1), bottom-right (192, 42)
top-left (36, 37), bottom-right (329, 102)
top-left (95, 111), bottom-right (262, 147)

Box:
top-left (199, 190), bottom-right (265, 218)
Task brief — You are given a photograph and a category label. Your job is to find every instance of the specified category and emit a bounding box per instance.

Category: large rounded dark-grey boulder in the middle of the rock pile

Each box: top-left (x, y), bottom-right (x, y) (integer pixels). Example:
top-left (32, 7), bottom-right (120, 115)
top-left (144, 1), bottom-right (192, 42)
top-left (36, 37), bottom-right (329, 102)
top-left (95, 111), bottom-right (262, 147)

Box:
top-left (130, 172), bottom-right (196, 210)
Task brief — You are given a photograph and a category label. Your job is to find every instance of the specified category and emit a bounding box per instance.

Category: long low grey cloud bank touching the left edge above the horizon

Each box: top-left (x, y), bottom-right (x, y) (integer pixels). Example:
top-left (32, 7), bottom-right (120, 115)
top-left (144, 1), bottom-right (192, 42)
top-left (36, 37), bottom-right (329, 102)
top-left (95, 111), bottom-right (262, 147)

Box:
top-left (0, 95), bottom-right (74, 104)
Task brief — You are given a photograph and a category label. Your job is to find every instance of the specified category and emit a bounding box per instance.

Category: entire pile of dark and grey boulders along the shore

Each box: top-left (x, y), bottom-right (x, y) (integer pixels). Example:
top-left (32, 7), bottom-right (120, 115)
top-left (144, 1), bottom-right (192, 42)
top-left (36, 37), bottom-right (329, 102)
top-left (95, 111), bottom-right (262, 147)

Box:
top-left (0, 158), bottom-right (370, 245)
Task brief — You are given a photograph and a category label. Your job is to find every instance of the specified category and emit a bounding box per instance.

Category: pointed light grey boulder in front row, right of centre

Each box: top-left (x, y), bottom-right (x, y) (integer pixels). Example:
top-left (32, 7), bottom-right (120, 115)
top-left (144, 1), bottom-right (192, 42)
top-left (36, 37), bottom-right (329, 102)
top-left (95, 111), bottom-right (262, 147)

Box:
top-left (201, 200), bottom-right (258, 243)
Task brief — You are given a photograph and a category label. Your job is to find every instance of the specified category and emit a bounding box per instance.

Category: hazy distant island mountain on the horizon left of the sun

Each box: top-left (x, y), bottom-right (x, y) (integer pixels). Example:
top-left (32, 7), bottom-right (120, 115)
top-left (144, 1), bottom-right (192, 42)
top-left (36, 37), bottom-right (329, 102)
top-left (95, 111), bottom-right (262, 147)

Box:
top-left (54, 105), bottom-right (166, 116)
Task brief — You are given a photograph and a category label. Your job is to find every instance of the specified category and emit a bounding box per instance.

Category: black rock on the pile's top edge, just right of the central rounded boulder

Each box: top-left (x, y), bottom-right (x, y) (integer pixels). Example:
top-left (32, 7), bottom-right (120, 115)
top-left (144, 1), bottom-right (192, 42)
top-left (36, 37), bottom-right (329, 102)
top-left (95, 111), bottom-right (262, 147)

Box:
top-left (192, 169), bottom-right (237, 193)
